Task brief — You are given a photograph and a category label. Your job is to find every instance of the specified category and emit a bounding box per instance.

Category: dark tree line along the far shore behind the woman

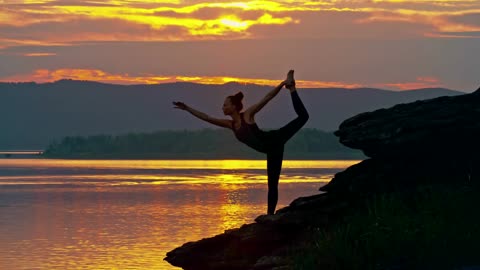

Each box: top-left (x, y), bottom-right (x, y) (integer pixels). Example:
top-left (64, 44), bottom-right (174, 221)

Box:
top-left (44, 128), bottom-right (363, 159)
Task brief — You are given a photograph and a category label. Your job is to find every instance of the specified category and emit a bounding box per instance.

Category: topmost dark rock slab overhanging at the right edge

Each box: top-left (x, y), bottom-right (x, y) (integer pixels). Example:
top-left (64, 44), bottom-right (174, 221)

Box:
top-left (335, 89), bottom-right (480, 157)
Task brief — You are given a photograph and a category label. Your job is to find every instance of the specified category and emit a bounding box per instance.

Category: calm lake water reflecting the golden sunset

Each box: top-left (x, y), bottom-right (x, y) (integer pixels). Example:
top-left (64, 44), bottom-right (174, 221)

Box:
top-left (0, 159), bottom-right (357, 269)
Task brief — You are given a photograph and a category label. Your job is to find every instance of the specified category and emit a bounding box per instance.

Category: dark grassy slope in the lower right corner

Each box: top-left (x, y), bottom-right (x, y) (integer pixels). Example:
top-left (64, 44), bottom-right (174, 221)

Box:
top-left (293, 186), bottom-right (480, 270)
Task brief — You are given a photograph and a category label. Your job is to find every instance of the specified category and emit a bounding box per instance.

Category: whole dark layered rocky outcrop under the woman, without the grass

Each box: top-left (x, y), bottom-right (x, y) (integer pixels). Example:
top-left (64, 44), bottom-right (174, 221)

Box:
top-left (165, 86), bottom-right (480, 270)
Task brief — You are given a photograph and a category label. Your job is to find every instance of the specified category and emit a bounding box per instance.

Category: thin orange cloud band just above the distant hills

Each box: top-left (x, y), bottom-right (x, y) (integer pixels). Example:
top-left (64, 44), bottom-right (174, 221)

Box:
top-left (0, 68), bottom-right (458, 92)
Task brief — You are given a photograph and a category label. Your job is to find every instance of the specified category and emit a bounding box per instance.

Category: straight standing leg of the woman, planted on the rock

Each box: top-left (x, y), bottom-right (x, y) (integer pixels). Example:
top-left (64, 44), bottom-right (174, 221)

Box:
top-left (267, 145), bottom-right (283, 215)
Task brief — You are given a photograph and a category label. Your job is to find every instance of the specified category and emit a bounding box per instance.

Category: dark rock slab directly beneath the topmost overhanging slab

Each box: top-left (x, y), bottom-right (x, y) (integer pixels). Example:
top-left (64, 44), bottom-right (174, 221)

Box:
top-left (320, 156), bottom-right (480, 196)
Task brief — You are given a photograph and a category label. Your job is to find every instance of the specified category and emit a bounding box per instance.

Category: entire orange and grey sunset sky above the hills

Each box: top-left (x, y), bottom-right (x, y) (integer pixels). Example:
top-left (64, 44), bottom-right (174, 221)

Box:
top-left (0, 0), bottom-right (480, 92)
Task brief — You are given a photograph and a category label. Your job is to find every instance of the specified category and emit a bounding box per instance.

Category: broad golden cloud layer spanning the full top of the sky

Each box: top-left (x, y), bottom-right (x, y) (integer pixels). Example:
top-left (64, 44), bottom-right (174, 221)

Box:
top-left (0, 0), bottom-right (480, 48)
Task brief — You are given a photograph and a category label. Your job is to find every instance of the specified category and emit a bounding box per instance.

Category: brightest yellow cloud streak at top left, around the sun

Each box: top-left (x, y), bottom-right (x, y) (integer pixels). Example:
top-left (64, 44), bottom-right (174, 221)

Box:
top-left (0, 1), bottom-right (300, 36)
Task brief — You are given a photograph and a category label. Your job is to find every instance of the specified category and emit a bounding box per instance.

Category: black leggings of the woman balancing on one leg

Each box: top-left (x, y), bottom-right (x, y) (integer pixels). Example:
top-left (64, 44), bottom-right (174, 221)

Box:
top-left (267, 91), bottom-right (309, 214)
